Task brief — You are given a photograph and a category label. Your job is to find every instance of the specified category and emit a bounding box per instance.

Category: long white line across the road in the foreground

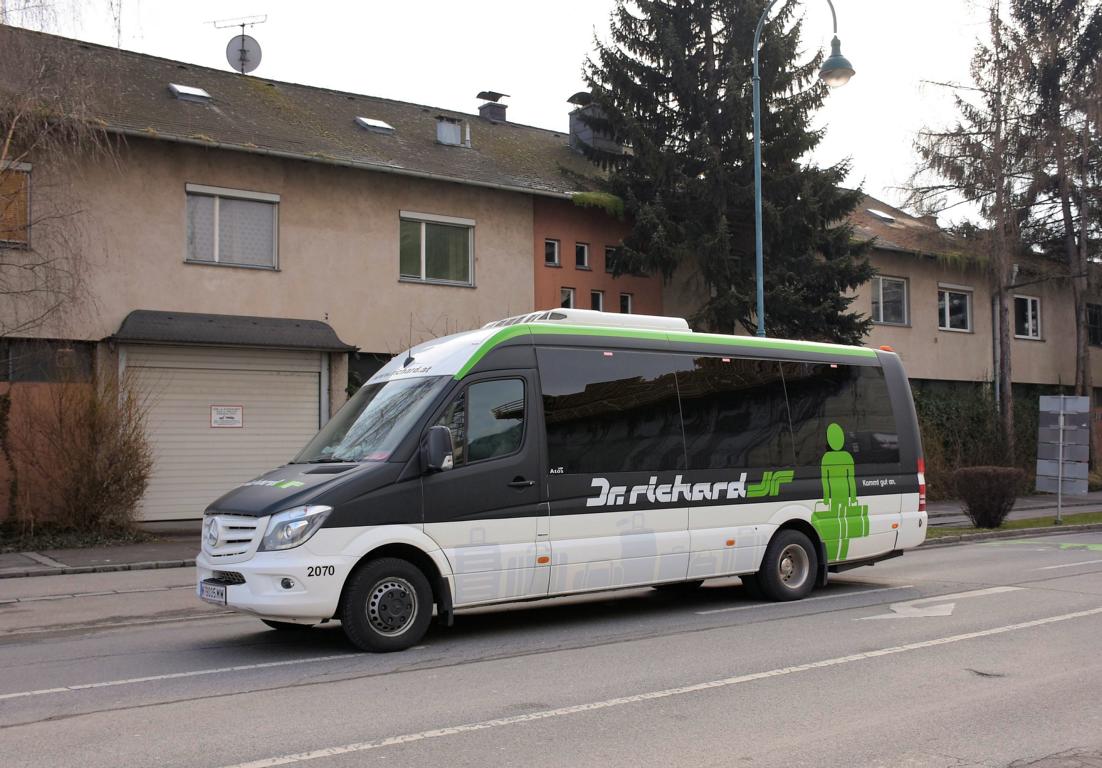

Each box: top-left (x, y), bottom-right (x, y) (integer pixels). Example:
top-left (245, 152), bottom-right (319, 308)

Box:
top-left (214, 608), bottom-right (1102, 768)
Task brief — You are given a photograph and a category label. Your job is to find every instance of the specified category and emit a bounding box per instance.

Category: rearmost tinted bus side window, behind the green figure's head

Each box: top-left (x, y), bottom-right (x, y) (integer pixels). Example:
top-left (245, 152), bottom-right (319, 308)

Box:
top-left (782, 363), bottom-right (899, 466)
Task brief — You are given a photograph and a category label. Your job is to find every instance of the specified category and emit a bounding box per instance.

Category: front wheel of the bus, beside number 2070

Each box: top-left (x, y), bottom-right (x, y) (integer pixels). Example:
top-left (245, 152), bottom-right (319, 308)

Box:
top-left (341, 558), bottom-right (433, 653)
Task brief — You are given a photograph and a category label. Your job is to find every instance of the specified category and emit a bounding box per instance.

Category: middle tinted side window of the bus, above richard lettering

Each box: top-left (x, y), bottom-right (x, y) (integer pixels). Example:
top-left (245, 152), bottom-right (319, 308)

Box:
top-left (678, 357), bottom-right (792, 469)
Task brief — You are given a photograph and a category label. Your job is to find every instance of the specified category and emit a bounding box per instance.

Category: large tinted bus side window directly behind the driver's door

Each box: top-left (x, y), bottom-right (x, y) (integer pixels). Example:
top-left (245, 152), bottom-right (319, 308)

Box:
top-left (538, 349), bottom-right (692, 474)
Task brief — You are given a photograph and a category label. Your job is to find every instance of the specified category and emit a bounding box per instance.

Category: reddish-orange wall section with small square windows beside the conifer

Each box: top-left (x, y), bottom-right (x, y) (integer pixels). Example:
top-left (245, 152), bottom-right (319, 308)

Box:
top-left (529, 197), bottom-right (662, 315)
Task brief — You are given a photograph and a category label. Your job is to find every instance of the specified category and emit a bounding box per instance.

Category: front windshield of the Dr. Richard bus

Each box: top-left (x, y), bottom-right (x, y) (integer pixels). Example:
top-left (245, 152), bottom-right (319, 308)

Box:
top-left (292, 376), bottom-right (449, 464)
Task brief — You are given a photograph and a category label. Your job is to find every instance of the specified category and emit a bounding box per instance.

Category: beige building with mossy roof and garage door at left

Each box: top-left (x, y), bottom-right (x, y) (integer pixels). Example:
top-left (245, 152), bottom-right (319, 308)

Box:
top-left (0, 25), bottom-right (603, 520)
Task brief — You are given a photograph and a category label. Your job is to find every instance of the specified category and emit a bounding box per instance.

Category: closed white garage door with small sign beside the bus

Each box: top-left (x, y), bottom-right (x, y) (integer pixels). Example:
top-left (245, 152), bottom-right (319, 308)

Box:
top-left (123, 346), bottom-right (327, 520)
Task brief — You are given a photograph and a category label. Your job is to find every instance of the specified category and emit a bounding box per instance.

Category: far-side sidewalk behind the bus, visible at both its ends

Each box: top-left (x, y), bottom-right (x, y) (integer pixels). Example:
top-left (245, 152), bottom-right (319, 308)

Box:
top-left (0, 491), bottom-right (1102, 578)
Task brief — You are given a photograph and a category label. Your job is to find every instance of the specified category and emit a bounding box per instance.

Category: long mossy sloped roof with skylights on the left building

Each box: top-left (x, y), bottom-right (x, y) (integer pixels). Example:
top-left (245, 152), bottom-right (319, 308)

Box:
top-left (0, 25), bottom-right (595, 196)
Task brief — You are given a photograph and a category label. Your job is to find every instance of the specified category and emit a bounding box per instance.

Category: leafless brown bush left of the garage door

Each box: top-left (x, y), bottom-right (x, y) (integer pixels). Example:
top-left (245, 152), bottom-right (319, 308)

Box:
top-left (11, 372), bottom-right (153, 536)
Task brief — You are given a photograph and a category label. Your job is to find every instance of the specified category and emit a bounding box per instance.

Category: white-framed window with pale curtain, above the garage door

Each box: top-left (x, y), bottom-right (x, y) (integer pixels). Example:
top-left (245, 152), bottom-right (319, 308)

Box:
top-left (185, 184), bottom-right (279, 269)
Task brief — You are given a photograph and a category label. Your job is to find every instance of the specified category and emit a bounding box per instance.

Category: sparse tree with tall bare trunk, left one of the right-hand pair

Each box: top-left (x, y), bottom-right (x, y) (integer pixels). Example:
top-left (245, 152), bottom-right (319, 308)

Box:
top-left (909, 0), bottom-right (1033, 458)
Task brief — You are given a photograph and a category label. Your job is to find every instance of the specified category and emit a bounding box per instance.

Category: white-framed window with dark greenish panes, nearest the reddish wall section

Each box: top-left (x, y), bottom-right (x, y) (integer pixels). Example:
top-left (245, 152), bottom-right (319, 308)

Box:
top-left (398, 210), bottom-right (475, 285)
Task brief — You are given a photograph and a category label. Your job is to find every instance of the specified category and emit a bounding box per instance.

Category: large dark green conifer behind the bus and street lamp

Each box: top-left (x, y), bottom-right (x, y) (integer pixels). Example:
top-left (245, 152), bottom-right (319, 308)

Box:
top-left (581, 0), bottom-right (873, 343)
